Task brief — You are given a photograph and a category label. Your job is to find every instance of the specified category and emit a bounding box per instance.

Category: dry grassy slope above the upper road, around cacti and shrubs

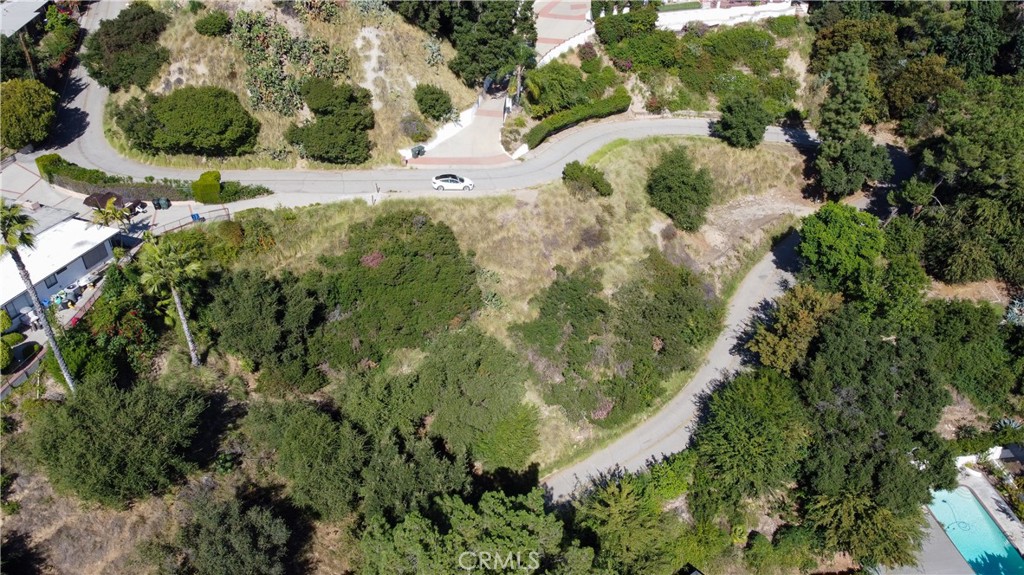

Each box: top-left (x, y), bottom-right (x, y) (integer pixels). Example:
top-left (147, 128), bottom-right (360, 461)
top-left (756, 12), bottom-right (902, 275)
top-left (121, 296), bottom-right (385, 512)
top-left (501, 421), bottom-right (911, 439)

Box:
top-left (105, 0), bottom-right (476, 169)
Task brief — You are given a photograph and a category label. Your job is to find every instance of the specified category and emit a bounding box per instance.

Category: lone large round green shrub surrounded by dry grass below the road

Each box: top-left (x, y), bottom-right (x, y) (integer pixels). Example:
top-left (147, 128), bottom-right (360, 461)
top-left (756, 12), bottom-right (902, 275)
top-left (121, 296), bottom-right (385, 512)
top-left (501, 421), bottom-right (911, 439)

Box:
top-left (647, 147), bottom-right (715, 231)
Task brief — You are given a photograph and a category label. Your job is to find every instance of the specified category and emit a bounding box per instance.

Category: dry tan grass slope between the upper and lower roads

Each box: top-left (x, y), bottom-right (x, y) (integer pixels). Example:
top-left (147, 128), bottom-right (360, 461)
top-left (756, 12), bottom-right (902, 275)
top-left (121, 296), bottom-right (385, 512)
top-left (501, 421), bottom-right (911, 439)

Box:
top-left (235, 137), bottom-right (813, 465)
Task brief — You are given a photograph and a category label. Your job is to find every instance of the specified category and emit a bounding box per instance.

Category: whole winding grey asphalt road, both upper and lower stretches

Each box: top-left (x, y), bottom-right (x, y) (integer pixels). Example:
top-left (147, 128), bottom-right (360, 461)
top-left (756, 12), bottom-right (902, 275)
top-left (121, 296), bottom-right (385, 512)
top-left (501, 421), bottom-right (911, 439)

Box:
top-left (29, 2), bottom-right (831, 499)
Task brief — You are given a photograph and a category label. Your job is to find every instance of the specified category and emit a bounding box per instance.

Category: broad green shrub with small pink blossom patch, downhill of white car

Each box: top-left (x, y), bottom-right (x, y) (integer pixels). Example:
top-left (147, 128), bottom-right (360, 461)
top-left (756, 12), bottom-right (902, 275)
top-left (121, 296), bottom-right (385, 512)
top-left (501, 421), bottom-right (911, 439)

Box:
top-left (313, 211), bottom-right (481, 368)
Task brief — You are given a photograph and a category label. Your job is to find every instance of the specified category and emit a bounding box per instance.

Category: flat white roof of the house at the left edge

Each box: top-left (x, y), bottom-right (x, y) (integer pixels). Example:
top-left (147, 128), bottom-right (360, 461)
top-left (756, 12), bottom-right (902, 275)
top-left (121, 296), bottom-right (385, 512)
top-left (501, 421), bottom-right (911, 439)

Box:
top-left (0, 219), bottom-right (118, 304)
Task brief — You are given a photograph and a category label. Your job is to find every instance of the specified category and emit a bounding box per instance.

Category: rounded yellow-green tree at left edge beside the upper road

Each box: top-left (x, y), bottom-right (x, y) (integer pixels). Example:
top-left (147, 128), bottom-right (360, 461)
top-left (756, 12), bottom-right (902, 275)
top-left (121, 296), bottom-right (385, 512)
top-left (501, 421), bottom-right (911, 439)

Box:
top-left (0, 80), bottom-right (57, 149)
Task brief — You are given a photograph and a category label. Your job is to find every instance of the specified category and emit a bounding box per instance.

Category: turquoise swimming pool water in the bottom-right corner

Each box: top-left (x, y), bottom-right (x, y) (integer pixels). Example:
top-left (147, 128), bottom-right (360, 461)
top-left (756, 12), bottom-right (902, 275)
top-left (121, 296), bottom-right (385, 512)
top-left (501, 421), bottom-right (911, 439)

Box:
top-left (928, 486), bottom-right (1024, 575)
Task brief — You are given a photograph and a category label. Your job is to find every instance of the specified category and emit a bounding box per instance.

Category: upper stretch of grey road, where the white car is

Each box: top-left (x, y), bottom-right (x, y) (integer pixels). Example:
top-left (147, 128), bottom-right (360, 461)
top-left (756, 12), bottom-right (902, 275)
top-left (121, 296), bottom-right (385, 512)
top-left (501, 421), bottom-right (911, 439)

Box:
top-left (39, 2), bottom-right (816, 205)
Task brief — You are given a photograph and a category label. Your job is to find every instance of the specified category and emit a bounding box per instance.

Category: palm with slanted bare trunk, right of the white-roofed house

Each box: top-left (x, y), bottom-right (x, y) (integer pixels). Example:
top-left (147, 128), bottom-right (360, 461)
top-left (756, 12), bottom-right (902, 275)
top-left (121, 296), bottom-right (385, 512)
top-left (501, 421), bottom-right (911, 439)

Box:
top-left (139, 235), bottom-right (205, 367)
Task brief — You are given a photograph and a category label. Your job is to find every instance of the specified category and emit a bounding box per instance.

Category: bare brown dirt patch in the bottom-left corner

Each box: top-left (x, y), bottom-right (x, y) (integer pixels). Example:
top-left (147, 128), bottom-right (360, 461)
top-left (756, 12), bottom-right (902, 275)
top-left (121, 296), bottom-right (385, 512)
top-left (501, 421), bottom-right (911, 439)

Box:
top-left (3, 474), bottom-right (173, 575)
